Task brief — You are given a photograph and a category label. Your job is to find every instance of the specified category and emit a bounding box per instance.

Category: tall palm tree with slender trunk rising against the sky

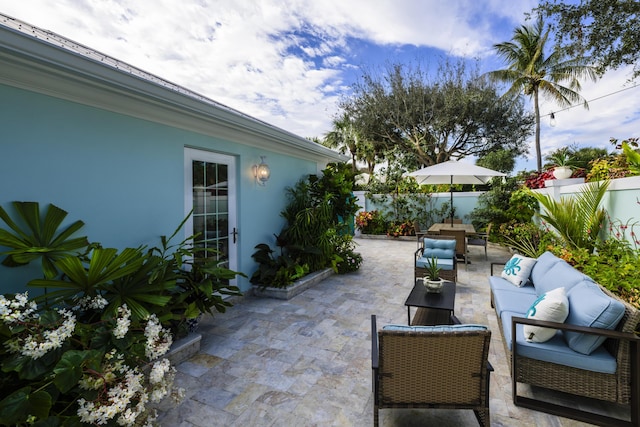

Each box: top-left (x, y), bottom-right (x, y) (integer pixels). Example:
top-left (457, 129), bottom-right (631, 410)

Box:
top-left (486, 18), bottom-right (597, 171)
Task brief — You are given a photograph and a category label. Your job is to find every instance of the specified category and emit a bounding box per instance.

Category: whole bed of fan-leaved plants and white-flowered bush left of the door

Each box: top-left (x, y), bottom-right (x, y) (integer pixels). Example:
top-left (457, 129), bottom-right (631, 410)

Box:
top-left (0, 202), bottom-right (239, 426)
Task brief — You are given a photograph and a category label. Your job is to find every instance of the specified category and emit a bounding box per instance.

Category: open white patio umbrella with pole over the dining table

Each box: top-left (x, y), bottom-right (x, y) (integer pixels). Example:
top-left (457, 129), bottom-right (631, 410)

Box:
top-left (409, 160), bottom-right (506, 224)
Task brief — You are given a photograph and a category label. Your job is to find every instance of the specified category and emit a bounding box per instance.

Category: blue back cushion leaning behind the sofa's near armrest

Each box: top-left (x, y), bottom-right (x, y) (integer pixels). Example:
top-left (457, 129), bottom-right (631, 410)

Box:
top-left (564, 280), bottom-right (624, 354)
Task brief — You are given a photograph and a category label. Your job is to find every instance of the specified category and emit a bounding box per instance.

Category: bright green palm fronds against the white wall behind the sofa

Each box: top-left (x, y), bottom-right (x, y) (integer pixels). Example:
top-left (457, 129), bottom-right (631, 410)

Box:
top-left (531, 181), bottom-right (609, 252)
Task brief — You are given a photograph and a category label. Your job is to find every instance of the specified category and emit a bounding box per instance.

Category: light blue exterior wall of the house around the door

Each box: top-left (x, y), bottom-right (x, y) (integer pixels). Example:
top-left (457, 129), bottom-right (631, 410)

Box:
top-left (0, 85), bottom-right (325, 293)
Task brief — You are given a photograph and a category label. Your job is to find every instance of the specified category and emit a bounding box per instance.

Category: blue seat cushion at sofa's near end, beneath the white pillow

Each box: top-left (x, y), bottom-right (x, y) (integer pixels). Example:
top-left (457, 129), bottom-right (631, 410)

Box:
top-left (500, 311), bottom-right (617, 374)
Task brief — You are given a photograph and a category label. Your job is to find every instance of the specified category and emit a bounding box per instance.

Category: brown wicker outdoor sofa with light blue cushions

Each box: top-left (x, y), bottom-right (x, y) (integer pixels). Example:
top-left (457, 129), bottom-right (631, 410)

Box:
top-left (489, 252), bottom-right (640, 426)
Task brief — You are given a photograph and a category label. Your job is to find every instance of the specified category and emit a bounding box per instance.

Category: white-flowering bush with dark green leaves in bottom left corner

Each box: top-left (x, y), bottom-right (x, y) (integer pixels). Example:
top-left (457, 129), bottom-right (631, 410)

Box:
top-left (0, 293), bottom-right (183, 426)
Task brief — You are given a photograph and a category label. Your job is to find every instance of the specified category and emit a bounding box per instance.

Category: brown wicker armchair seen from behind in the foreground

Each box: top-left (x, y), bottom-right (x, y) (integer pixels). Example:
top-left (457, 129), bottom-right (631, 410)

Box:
top-left (371, 315), bottom-right (493, 426)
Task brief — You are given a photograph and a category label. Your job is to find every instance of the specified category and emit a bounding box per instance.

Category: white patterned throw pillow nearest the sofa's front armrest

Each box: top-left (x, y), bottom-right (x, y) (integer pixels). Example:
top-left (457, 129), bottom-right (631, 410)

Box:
top-left (523, 288), bottom-right (569, 342)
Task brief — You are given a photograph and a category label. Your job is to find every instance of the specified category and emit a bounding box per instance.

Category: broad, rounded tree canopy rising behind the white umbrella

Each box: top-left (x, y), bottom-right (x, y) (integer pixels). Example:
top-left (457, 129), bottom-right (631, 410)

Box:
top-left (340, 60), bottom-right (533, 168)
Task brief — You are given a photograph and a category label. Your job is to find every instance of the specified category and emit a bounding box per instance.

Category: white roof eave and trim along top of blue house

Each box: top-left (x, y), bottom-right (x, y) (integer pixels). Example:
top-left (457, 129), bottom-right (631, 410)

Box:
top-left (0, 14), bottom-right (348, 162)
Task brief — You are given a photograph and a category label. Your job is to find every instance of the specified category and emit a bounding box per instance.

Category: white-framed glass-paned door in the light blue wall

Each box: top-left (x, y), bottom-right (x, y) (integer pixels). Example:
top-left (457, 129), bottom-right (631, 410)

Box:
top-left (184, 148), bottom-right (238, 285)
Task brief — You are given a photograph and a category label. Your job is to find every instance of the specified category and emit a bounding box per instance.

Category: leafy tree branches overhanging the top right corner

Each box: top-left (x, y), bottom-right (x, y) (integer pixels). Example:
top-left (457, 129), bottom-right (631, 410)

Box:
top-left (536, 0), bottom-right (640, 79)
